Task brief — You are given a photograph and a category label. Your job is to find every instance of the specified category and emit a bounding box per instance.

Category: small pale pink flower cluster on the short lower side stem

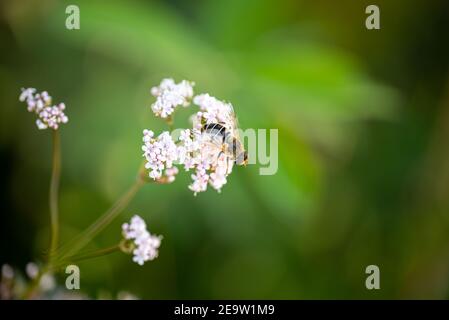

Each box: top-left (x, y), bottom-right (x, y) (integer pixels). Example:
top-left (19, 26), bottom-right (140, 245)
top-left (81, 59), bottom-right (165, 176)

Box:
top-left (122, 215), bottom-right (162, 265)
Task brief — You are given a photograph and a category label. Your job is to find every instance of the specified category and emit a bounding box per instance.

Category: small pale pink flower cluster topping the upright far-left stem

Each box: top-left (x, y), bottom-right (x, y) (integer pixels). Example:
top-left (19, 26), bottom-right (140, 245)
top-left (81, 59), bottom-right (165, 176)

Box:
top-left (19, 88), bottom-right (69, 130)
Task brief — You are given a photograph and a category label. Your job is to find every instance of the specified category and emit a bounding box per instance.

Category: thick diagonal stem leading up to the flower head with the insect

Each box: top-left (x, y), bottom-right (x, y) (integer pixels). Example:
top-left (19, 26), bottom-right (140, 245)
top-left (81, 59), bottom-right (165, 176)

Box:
top-left (58, 173), bottom-right (145, 260)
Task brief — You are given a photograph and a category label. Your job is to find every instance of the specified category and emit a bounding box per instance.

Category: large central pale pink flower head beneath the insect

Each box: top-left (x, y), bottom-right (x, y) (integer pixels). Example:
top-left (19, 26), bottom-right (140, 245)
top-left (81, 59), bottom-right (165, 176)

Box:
top-left (142, 79), bottom-right (243, 195)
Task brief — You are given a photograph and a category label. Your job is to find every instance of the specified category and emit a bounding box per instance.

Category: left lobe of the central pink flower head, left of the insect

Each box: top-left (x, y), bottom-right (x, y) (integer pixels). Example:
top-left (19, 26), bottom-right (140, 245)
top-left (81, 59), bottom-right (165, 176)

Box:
top-left (142, 130), bottom-right (178, 182)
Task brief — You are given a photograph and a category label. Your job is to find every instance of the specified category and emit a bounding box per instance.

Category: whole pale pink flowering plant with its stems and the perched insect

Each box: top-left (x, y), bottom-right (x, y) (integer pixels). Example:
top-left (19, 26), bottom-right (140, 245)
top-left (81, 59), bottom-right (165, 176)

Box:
top-left (0, 78), bottom-right (247, 299)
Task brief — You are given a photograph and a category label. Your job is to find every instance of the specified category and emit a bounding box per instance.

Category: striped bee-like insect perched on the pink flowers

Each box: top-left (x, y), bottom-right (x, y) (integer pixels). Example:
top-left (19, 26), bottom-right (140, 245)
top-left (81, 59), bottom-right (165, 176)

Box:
top-left (201, 108), bottom-right (248, 165)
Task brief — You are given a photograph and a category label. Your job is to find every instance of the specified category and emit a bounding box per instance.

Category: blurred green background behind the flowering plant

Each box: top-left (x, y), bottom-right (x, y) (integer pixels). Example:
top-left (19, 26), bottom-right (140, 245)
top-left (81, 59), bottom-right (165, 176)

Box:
top-left (0, 0), bottom-right (449, 299)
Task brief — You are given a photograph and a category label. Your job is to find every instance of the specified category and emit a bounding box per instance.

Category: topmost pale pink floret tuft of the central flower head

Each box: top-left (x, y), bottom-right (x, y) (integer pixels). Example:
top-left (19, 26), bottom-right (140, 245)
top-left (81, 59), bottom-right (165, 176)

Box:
top-left (151, 78), bottom-right (194, 118)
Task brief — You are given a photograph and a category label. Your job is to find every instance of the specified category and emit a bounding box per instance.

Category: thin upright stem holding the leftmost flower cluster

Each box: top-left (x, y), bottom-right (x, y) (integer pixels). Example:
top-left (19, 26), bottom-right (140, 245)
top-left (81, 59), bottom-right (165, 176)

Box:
top-left (49, 130), bottom-right (61, 260)
